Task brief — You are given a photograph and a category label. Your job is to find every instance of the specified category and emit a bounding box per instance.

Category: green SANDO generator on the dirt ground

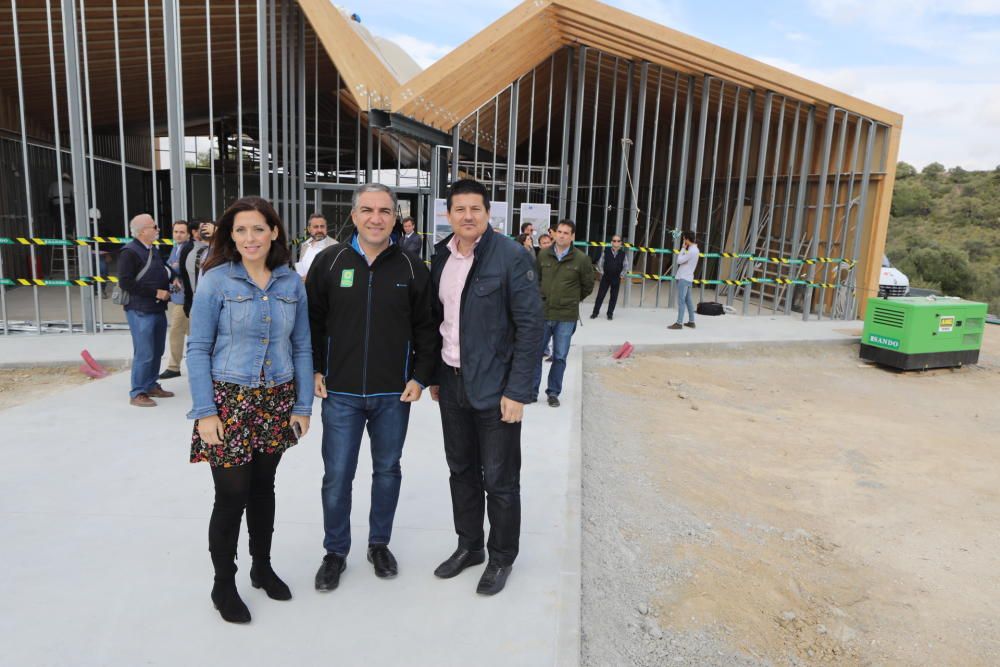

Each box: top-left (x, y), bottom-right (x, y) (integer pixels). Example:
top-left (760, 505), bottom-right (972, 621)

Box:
top-left (861, 296), bottom-right (986, 371)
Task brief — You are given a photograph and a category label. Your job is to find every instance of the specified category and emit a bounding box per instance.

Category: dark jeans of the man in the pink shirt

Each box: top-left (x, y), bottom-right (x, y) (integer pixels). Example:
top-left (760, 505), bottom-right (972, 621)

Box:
top-left (439, 366), bottom-right (521, 565)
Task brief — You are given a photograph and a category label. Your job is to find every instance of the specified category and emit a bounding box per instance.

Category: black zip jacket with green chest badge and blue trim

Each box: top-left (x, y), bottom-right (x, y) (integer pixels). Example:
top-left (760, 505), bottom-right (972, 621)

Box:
top-left (306, 239), bottom-right (438, 396)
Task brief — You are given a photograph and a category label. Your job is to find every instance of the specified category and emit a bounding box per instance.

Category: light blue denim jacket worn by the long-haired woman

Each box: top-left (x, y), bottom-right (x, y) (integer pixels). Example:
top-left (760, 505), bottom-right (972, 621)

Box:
top-left (187, 262), bottom-right (313, 419)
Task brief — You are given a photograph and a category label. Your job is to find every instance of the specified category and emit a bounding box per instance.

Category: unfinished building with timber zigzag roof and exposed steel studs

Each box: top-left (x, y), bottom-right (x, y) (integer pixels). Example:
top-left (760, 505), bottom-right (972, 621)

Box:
top-left (0, 0), bottom-right (902, 333)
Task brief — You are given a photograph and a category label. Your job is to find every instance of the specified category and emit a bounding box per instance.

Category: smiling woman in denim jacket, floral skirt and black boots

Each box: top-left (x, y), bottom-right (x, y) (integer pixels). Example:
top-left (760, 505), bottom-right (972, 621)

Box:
top-left (187, 197), bottom-right (313, 623)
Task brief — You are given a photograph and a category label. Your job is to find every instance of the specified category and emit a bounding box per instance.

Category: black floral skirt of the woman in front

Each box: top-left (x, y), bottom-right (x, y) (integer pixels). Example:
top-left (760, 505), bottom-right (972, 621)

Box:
top-left (191, 382), bottom-right (297, 468)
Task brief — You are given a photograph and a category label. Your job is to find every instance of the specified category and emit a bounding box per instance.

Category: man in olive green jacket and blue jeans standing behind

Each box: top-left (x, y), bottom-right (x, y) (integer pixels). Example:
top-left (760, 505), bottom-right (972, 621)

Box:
top-left (534, 220), bottom-right (594, 408)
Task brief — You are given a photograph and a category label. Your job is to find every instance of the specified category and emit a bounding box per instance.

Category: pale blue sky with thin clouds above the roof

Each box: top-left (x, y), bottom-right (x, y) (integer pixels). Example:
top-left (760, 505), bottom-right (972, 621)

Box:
top-left (347, 0), bottom-right (1000, 169)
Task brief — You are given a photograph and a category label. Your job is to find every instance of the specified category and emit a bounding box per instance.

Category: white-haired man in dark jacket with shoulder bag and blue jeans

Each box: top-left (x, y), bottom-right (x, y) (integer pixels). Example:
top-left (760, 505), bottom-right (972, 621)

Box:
top-left (118, 213), bottom-right (174, 408)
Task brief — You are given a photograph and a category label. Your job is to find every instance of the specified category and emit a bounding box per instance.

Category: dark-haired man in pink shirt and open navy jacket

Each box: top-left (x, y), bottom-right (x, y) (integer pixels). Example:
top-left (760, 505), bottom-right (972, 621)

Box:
top-left (431, 180), bottom-right (542, 595)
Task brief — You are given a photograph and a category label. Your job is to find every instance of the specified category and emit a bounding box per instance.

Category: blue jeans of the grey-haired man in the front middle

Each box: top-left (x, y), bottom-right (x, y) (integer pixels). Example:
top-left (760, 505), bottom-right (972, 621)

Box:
top-left (323, 393), bottom-right (410, 556)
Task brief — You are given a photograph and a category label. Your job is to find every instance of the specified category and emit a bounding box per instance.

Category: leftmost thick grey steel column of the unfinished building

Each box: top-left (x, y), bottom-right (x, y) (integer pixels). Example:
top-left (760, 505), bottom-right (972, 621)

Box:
top-left (61, 0), bottom-right (96, 333)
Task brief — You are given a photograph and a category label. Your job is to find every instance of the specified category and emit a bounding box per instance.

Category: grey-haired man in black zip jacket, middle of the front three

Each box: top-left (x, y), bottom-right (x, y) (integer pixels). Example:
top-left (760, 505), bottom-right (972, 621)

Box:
top-left (306, 183), bottom-right (437, 591)
